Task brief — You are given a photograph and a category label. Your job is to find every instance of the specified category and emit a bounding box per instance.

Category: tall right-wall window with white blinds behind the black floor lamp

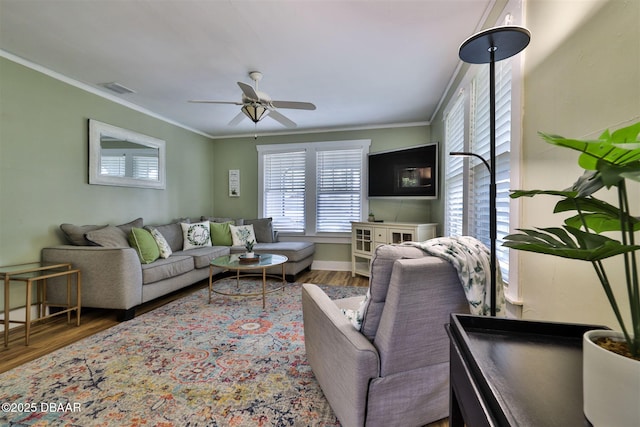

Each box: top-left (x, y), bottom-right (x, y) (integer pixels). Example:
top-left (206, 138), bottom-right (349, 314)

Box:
top-left (445, 59), bottom-right (512, 282)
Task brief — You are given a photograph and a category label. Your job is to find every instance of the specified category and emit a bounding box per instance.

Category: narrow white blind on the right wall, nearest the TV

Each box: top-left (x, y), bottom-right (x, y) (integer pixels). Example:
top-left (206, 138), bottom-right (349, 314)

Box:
top-left (444, 96), bottom-right (464, 236)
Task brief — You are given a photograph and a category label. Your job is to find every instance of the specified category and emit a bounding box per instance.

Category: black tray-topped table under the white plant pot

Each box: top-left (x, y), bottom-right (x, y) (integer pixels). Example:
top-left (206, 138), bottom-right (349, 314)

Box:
top-left (446, 314), bottom-right (608, 427)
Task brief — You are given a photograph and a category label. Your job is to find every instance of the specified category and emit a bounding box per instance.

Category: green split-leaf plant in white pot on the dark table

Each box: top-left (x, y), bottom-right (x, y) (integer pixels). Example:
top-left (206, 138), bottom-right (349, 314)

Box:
top-left (504, 122), bottom-right (640, 426)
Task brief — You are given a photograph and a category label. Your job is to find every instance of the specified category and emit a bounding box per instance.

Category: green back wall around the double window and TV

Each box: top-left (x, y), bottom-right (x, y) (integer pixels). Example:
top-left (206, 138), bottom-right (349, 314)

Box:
top-left (213, 126), bottom-right (435, 262)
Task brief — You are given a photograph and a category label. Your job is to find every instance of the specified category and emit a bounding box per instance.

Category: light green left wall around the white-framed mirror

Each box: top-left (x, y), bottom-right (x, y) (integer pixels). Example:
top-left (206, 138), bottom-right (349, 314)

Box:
top-left (0, 58), bottom-right (214, 310)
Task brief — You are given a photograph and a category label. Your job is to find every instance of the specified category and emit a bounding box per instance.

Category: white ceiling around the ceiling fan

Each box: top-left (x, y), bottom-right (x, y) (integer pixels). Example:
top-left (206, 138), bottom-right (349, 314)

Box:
top-left (0, 0), bottom-right (493, 137)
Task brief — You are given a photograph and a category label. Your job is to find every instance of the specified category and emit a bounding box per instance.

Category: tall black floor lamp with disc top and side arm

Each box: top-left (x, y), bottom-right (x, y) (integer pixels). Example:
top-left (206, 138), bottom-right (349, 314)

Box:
top-left (450, 26), bottom-right (531, 316)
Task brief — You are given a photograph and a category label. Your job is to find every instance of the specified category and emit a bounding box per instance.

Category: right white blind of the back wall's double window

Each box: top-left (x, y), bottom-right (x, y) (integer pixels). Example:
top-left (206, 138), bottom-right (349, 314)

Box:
top-left (316, 149), bottom-right (363, 232)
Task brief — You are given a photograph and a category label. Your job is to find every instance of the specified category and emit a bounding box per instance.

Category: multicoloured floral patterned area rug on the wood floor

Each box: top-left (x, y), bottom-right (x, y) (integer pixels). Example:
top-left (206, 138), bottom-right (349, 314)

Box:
top-left (0, 279), bottom-right (365, 427)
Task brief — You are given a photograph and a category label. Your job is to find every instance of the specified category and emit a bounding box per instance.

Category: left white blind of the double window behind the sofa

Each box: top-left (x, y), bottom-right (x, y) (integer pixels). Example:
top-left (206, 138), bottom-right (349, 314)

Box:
top-left (262, 150), bottom-right (306, 233)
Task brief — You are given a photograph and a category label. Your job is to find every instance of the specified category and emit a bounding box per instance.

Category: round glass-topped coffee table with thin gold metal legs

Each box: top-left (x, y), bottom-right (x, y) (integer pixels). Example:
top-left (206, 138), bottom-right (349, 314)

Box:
top-left (209, 254), bottom-right (289, 308)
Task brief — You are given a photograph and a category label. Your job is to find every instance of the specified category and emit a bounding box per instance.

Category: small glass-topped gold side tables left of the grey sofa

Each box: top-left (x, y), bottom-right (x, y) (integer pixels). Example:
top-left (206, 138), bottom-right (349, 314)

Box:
top-left (0, 262), bottom-right (82, 347)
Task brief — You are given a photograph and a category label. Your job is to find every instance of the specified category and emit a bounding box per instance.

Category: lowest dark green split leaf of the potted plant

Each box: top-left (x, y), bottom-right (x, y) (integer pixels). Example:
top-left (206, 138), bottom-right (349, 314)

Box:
top-left (503, 227), bottom-right (640, 261)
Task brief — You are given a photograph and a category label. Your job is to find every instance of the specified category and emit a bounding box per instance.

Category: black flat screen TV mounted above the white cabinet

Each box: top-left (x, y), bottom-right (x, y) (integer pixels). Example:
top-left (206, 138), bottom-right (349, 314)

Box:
top-left (369, 143), bottom-right (438, 199)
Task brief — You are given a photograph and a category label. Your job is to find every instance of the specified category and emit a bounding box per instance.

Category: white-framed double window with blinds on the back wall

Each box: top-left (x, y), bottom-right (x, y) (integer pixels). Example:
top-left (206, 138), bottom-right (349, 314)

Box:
top-left (257, 140), bottom-right (370, 236)
